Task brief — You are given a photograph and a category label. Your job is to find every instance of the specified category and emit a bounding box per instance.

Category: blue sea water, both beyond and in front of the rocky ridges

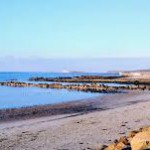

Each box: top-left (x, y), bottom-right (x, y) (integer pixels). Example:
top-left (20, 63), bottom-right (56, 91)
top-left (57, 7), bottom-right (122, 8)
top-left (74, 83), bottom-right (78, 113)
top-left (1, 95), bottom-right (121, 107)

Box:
top-left (0, 72), bottom-right (118, 109)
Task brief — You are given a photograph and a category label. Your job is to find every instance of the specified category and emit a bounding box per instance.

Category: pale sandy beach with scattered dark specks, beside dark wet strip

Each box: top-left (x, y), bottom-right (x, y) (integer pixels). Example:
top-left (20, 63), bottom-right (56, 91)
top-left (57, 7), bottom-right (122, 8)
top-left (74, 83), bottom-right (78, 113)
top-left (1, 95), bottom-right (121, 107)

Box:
top-left (0, 91), bottom-right (150, 150)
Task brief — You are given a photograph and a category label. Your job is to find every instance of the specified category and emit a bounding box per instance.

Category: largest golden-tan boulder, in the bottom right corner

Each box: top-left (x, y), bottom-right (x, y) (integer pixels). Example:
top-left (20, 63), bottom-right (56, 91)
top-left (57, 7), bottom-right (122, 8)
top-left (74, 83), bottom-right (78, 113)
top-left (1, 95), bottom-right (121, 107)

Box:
top-left (131, 131), bottom-right (150, 150)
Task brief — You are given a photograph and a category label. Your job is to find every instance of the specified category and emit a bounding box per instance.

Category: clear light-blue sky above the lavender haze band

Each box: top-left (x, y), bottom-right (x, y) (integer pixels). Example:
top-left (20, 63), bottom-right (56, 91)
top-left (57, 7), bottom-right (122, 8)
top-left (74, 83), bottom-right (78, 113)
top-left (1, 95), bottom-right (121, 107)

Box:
top-left (0, 0), bottom-right (150, 58)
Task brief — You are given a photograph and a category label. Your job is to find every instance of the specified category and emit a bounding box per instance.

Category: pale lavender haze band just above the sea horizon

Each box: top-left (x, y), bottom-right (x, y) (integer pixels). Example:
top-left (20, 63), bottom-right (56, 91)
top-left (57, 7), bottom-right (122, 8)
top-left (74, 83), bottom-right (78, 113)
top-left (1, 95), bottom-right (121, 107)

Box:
top-left (0, 58), bottom-right (150, 73)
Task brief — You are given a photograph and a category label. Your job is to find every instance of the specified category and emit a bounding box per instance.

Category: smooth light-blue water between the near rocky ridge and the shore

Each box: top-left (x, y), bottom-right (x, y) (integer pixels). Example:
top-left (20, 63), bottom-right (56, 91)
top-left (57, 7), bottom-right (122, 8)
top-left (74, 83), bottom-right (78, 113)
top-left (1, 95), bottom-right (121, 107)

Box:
top-left (0, 87), bottom-right (103, 109)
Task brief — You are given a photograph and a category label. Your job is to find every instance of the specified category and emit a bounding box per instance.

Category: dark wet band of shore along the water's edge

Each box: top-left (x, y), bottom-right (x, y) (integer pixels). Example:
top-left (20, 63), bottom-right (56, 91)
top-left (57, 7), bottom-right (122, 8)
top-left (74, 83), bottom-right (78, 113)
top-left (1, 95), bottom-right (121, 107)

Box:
top-left (0, 90), bottom-right (150, 122)
